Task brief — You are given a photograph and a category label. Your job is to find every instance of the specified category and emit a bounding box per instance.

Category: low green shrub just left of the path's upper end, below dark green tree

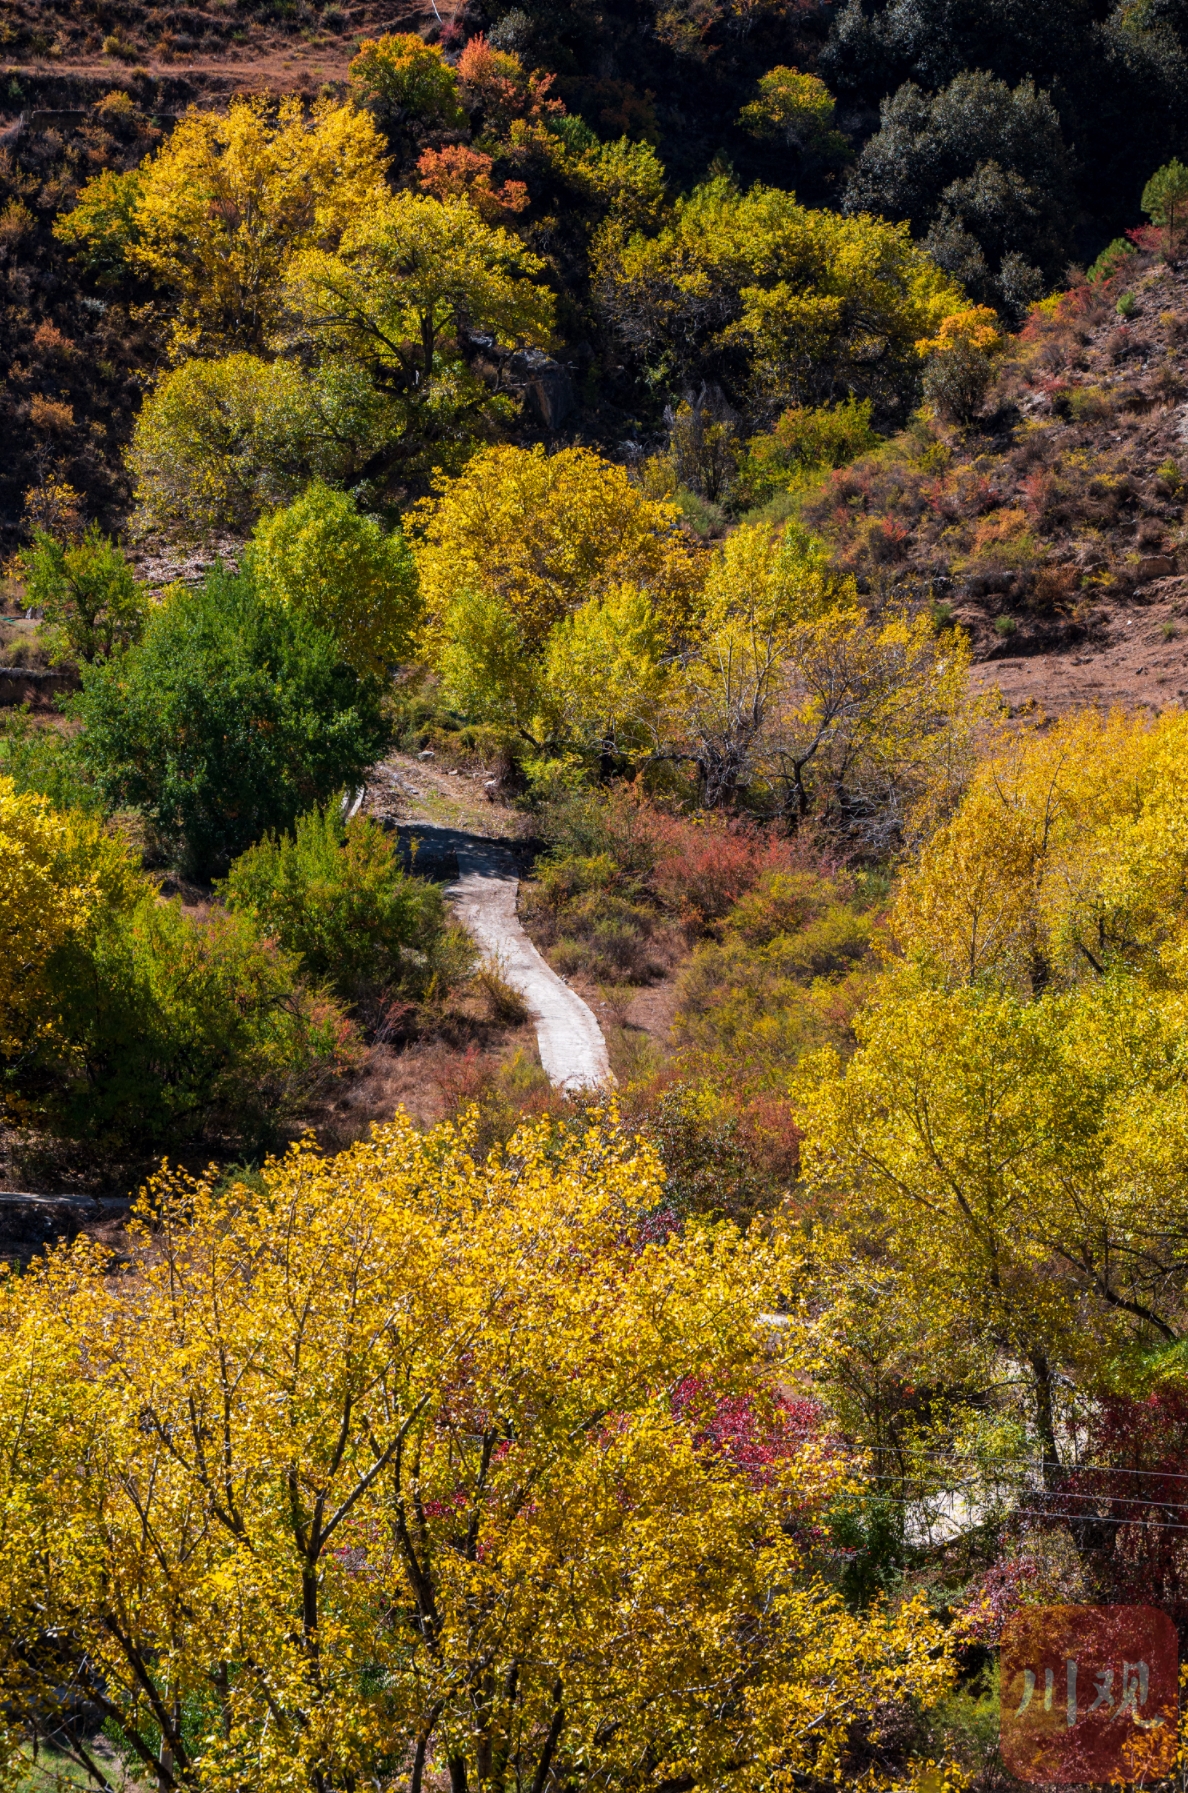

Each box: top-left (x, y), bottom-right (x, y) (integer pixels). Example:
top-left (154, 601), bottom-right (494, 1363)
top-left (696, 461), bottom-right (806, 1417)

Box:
top-left (222, 803), bottom-right (446, 997)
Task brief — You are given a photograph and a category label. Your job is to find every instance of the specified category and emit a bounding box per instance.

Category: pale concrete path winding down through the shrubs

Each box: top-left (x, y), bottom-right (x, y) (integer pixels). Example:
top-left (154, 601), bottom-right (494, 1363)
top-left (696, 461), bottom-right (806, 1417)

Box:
top-left (400, 821), bottom-right (615, 1090)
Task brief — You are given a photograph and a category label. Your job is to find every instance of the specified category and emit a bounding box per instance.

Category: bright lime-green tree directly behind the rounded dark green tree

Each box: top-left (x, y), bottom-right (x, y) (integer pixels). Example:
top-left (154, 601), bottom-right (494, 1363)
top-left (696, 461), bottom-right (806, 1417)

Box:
top-left (247, 481), bottom-right (418, 674)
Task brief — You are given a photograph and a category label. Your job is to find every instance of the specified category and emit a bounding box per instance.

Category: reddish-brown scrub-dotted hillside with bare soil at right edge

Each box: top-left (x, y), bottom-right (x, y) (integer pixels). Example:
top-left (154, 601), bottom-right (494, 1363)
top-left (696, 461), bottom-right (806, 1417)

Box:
top-left (805, 253), bottom-right (1188, 715)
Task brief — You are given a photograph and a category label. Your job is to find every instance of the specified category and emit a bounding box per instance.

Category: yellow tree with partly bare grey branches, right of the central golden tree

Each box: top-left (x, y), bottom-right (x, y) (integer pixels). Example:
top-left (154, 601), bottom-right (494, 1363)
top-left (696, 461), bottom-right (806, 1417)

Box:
top-left (668, 525), bottom-right (975, 821)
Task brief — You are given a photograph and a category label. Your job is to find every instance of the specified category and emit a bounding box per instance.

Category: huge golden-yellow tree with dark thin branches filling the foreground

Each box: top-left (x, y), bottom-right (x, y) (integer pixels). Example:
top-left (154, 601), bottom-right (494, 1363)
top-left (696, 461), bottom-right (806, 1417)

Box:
top-left (0, 1119), bottom-right (950, 1793)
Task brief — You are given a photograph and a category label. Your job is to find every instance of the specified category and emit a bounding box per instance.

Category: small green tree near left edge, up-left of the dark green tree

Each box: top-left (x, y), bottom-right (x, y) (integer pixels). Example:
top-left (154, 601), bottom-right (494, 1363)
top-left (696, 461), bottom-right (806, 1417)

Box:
top-left (22, 524), bottom-right (147, 663)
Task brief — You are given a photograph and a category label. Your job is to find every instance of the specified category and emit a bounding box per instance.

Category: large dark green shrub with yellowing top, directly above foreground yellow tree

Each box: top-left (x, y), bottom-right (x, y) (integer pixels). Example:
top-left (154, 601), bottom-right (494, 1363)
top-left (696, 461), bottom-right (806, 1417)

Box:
top-left (13, 891), bottom-right (353, 1155)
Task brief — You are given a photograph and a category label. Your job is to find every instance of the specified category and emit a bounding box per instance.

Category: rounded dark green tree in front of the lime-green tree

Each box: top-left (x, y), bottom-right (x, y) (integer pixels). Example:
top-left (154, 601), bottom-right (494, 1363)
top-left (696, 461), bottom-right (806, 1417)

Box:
top-left (75, 568), bottom-right (387, 877)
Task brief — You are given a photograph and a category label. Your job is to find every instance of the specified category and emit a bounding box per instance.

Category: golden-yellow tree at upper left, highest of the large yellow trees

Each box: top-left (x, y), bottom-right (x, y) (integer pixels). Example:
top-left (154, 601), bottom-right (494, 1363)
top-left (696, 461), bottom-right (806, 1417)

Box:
top-left (56, 99), bottom-right (387, 355)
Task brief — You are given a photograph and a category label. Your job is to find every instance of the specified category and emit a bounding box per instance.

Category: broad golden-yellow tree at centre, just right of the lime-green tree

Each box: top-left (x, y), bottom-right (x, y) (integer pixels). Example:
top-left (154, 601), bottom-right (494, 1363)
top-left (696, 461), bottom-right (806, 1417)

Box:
top-left (412, 446), bottom-right (701, 746)
